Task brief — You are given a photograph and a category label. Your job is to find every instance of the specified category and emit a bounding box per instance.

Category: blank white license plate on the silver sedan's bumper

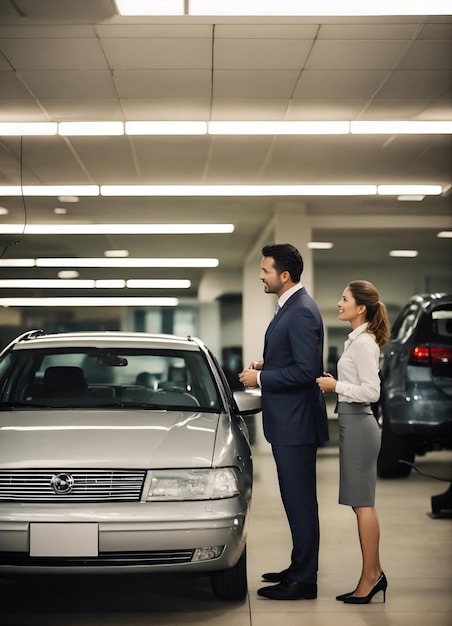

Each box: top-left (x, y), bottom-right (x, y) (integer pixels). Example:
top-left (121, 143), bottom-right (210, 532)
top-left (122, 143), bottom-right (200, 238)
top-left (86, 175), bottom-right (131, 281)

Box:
top-left (30, 522), bottom-right (99, 557)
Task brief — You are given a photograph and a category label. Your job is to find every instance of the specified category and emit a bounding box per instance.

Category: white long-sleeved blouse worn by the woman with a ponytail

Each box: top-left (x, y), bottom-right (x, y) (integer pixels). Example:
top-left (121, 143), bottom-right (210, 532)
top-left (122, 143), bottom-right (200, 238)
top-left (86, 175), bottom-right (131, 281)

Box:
top-left (336, 323), bottom-right (380, 402)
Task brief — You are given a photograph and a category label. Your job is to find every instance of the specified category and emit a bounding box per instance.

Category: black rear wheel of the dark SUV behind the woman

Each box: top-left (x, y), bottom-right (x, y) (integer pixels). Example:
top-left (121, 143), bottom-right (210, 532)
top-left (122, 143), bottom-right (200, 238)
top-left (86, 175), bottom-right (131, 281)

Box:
top-left (377, 406), bottom-right (414, 478)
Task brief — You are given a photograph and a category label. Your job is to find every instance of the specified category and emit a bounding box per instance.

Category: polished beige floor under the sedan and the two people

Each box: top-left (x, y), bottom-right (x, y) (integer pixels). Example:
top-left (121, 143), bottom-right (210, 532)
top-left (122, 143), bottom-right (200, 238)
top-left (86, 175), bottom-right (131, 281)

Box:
top-left (0, 422), bottom-right (452, 626)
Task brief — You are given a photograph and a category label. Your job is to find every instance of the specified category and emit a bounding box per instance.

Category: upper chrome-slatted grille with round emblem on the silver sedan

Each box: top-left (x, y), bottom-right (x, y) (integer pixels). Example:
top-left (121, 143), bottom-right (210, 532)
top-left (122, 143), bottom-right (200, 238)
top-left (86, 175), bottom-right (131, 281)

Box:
top-left (0, 469), bottom-right (145, 503)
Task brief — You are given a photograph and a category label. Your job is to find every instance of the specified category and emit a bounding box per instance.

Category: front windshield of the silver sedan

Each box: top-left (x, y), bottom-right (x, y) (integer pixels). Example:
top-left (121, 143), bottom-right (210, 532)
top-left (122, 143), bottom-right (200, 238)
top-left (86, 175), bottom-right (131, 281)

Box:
top-left (0, 348), bottom-right (222, 412)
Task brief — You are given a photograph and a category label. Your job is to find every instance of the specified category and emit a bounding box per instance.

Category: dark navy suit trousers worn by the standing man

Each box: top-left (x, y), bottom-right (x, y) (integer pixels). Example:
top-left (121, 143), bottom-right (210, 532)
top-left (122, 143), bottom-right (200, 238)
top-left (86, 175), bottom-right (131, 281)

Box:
top-left (272, 444), bottom-right (320, 584)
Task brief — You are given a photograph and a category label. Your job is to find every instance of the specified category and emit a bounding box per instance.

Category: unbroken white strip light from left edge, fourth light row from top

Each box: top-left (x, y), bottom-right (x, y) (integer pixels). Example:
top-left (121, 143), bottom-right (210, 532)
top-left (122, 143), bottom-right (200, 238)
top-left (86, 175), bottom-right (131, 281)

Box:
top-left (0, 224), bottom-right (234, 235)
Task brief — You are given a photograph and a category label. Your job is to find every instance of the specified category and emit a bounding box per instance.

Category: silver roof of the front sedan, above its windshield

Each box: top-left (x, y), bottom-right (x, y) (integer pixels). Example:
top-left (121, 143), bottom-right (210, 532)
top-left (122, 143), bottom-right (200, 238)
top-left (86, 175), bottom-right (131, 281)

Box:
top-left (8, 331), bottom-right (203, 352)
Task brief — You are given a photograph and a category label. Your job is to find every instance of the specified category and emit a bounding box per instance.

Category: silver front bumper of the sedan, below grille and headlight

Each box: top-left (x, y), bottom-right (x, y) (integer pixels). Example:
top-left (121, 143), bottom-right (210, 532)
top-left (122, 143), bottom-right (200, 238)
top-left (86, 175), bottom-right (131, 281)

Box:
top-left (0, 498), bottom-right (248, 575)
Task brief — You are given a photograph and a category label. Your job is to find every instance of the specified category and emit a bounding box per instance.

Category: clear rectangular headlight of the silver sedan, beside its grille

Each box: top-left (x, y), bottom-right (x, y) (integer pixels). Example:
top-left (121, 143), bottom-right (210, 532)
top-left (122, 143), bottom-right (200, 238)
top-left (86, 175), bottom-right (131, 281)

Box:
top-left (146, 468), bottom-right (239, 501)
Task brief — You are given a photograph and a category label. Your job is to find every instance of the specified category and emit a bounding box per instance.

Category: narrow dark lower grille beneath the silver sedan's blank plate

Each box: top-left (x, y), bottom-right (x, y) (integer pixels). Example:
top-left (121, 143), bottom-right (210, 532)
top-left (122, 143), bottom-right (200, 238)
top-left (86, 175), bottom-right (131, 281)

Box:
top-left (0, 549), bottom-right (194, 567)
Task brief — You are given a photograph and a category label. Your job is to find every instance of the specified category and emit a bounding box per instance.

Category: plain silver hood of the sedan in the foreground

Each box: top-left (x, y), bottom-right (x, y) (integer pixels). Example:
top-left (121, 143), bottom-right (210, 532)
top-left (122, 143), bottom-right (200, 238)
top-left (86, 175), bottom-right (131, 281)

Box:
top-left (0, 409), bottom-right (219, 469)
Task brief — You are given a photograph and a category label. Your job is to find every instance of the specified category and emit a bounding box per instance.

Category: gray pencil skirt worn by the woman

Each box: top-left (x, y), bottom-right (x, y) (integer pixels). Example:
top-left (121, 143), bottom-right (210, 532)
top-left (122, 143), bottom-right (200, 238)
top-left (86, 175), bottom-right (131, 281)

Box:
top-left (337, 402), bottom-right (381, 506)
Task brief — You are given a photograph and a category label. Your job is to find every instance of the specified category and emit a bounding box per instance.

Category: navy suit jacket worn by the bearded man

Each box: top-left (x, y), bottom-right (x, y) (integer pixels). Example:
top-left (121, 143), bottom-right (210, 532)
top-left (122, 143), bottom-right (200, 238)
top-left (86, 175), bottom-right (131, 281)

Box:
top-left (260, 287), bottom-right (328, 445)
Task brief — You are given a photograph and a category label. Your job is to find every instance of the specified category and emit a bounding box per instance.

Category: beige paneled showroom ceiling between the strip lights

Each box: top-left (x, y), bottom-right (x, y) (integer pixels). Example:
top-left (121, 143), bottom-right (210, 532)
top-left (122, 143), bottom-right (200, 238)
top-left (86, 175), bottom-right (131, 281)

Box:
top-left (0, 0), bottom-right (452, 304)
